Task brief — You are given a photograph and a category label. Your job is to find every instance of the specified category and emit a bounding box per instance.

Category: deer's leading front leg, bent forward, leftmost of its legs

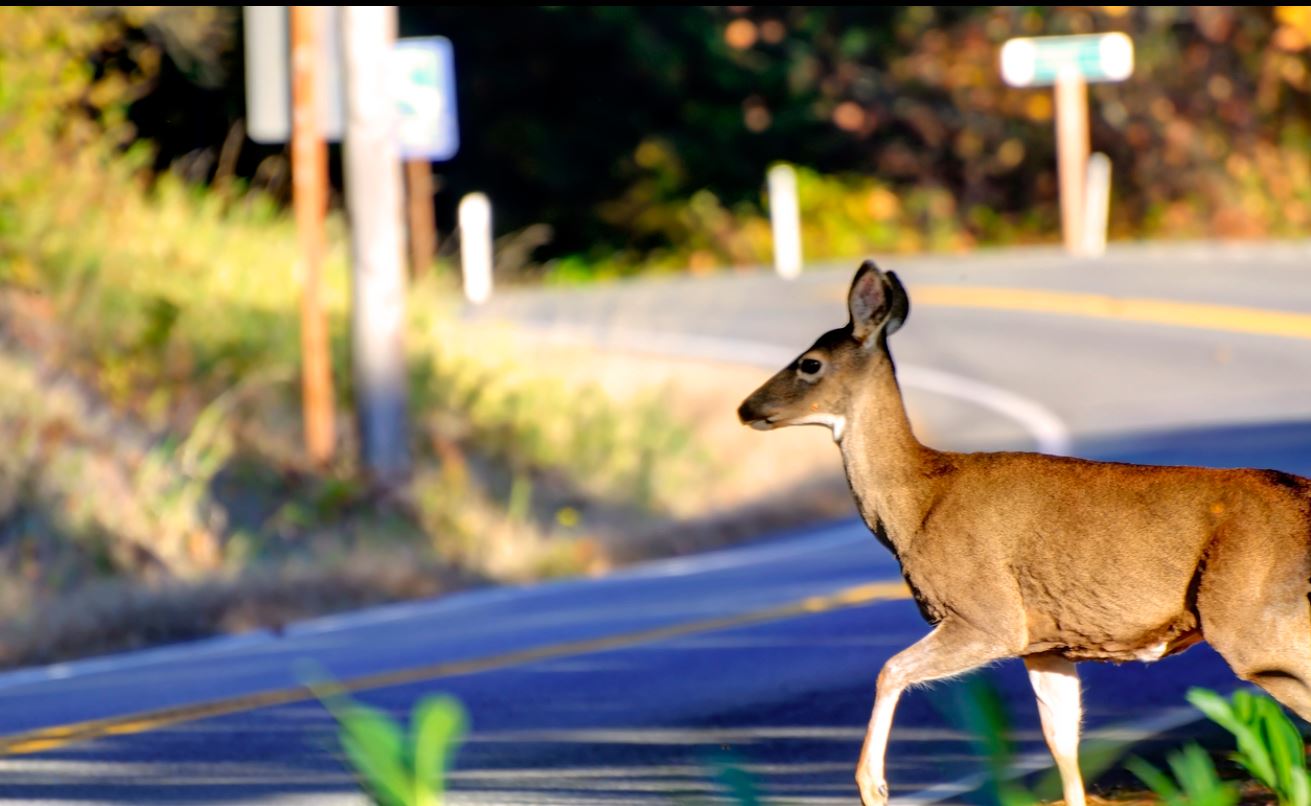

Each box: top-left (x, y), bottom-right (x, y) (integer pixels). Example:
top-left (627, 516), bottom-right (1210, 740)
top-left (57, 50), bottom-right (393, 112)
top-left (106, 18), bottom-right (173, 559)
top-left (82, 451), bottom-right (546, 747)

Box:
top-left (856, 620), bottom-right (1015, 806)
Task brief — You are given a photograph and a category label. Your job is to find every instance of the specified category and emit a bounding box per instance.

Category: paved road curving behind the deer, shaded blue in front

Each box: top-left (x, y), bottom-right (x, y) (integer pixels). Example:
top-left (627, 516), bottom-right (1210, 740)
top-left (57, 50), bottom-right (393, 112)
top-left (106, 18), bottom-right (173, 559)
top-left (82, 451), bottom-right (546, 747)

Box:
top-left (0, 246), bottom-right (1311, 803)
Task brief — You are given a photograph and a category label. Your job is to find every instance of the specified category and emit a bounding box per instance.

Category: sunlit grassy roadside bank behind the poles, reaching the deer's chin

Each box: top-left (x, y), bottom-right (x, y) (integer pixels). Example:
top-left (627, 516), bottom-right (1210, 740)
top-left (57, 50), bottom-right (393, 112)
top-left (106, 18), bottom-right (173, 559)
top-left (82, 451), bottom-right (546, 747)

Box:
top-left (0, 160), bottom-right (850, 664)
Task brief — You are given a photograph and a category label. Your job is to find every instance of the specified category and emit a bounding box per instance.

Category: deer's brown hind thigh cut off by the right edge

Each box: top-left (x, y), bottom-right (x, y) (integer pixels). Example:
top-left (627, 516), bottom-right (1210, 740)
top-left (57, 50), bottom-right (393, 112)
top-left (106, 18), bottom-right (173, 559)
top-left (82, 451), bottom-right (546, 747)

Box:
top-left (1197, 531), bottom-right (1311, 722)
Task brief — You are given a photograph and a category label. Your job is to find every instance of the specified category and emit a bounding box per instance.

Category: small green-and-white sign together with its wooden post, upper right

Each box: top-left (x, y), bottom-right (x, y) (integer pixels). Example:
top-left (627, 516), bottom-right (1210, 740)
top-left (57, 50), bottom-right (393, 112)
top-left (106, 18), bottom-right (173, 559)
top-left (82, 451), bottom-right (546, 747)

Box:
top-left (1002, 33), bottom-right (1134, 254)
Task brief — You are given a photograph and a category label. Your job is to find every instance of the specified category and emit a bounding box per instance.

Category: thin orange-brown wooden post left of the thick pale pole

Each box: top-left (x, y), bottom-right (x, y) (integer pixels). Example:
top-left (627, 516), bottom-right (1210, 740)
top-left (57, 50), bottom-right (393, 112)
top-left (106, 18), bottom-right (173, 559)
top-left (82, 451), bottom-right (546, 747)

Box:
top-left (291, 5), bottom-right (337, 467)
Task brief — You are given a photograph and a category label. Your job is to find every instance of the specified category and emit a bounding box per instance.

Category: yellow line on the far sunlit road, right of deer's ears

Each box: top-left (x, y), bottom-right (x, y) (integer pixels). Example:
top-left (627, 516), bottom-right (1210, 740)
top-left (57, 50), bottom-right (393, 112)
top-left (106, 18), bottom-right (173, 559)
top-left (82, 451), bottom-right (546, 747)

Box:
top-left (870, 286), bottom-right (1311, 339)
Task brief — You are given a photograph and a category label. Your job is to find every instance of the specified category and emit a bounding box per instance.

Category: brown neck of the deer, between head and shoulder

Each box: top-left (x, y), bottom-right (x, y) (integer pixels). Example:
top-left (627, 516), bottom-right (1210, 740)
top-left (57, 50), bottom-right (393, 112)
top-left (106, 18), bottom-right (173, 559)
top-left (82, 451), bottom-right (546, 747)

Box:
top-left (839, 358), bottom-right (936, 556)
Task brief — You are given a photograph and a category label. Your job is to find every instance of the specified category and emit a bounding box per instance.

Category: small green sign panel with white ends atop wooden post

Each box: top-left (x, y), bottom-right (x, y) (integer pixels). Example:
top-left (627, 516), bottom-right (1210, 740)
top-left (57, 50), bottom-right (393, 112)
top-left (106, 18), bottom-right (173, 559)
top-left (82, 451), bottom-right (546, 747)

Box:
top-left (1002, 33), bottom-right (1134, 86)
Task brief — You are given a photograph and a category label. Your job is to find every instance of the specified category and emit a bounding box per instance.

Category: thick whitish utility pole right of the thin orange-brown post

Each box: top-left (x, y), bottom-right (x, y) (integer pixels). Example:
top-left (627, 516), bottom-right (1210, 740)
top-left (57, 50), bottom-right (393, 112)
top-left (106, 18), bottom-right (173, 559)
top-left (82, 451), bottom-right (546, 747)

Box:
top-left (341, 5), bottom-right (409, 485)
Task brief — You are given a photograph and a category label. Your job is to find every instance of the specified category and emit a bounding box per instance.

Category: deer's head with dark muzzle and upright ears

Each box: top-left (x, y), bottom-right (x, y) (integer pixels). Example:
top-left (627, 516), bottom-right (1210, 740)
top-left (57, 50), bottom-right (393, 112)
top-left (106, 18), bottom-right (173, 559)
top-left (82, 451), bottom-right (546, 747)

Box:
top-left (738, 261), bottom-right (910, 440)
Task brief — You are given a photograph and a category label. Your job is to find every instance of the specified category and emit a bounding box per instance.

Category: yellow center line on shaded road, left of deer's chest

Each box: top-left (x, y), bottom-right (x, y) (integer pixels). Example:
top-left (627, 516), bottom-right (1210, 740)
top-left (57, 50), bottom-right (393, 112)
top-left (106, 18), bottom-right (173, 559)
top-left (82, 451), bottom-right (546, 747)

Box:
top-left (0, 581), bottom-right (910, 756)
